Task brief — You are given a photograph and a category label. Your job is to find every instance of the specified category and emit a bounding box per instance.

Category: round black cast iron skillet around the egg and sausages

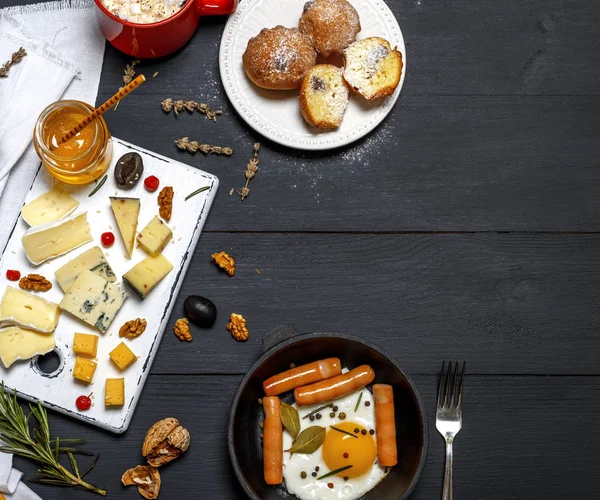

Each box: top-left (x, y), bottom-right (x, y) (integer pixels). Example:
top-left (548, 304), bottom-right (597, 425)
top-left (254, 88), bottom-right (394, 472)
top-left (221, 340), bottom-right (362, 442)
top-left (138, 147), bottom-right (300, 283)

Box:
top-left (228, 326), bottom-right (428, 500)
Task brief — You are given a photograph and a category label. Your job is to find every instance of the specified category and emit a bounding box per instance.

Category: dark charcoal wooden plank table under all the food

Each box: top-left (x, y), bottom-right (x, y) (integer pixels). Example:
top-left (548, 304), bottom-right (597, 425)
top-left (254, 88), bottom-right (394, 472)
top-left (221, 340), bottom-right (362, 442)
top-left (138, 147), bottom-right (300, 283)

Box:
top-left (2, 0), bottom-right (600, 500)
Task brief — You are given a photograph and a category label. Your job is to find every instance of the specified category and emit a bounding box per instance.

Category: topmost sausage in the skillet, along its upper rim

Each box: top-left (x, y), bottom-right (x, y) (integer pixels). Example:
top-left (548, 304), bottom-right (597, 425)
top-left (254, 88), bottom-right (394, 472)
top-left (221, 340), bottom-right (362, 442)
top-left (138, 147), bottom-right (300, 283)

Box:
top-left (263, 358), bottom-right (342, 396)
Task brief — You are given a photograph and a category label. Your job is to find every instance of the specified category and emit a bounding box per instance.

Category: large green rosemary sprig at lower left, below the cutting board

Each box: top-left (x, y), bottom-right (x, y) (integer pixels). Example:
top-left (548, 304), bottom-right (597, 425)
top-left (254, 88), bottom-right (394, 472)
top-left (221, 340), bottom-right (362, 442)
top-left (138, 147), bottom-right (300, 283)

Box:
top-left (0, 382), bottom-right (106, 496)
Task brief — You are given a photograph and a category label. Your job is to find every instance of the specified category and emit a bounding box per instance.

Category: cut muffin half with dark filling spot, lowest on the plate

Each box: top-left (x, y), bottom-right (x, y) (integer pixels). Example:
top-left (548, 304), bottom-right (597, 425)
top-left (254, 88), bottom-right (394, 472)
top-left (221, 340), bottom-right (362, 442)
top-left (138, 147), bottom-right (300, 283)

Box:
top-left (300, 64), bottom-right (349, 128)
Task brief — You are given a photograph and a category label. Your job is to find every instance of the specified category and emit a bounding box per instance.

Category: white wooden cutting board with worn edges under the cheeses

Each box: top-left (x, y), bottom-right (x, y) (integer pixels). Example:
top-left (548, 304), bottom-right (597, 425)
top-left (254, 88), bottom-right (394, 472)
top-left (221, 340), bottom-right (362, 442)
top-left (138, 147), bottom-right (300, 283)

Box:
top-left (0, 138), bottom-right (219, 433)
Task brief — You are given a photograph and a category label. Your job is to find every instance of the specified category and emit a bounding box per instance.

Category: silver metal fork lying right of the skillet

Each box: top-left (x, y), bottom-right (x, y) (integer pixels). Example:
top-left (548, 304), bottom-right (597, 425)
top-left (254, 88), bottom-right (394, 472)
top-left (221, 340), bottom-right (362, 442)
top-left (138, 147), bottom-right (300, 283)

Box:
top-left (435, 361), bottom-right (466, 500)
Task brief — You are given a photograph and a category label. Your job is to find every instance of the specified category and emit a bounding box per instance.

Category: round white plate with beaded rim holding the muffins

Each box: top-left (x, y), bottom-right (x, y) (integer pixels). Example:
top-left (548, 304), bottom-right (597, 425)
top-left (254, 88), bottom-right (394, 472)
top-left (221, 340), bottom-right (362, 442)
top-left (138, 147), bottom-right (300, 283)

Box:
top-left (219, 0), bottom-right (406, 150)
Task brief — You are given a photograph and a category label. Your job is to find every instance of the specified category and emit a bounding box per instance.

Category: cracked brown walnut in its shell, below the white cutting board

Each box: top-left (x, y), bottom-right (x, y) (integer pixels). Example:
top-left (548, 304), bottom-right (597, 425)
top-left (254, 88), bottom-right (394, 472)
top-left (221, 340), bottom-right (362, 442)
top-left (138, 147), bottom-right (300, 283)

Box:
top-left (142, 418), bottom-right (190, 467)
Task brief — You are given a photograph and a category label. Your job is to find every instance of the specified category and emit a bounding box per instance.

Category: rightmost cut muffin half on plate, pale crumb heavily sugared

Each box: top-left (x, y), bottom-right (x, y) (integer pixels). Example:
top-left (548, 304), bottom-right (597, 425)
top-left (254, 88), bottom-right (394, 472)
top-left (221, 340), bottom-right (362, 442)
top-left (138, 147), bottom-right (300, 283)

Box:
top-left (343, 36), bottom-right (402, 100)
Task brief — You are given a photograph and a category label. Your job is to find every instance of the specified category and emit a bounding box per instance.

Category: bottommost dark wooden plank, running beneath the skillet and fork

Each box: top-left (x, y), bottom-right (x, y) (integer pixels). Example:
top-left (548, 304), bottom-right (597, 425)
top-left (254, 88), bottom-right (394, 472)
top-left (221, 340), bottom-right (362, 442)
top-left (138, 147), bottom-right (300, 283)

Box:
top-left (18, 375), bottom-right (600, 500)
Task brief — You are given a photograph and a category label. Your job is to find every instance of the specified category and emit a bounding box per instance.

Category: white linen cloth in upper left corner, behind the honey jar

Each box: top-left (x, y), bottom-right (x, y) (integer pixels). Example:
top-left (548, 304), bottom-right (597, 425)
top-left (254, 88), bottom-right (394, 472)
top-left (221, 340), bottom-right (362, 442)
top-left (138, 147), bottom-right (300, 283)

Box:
top-left (0, 0), bottom-right (105, 252)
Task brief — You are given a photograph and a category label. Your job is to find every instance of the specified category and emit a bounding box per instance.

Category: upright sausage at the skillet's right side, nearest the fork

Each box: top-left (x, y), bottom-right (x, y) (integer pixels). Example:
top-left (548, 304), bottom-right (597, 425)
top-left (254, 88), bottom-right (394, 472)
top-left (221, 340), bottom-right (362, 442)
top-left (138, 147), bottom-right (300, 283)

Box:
top-left (373, 384), bottom-right (398, 467)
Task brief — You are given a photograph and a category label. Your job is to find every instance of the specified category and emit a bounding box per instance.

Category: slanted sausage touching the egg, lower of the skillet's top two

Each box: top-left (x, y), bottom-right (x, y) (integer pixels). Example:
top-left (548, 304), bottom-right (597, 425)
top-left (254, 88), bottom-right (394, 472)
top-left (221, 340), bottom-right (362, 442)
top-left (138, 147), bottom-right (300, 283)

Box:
top-left (294, 365), bottom-right (375, 406)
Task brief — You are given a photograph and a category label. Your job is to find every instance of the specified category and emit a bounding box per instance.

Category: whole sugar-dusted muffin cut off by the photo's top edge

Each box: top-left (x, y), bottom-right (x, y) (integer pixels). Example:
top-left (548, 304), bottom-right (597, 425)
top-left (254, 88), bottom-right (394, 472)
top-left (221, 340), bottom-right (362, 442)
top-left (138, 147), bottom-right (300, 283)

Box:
top-left (298, 0), bottom-right (360, 57)
